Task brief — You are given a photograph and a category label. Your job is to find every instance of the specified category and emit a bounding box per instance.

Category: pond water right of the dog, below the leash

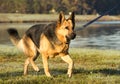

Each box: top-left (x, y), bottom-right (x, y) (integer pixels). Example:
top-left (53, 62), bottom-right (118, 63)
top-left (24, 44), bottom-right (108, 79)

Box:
top-left (71, 21), bottom-right (120, 50)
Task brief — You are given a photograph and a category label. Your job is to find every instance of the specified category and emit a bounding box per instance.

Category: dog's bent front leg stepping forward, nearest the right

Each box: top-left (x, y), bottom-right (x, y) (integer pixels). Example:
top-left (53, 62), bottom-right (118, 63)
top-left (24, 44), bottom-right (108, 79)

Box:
top-left (61, 55), bottom-right (73, 77)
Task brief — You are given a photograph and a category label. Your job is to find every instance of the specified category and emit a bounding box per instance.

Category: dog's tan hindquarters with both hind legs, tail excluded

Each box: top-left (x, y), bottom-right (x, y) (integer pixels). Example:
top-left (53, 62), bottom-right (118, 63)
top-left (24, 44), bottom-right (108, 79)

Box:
top-left (19, 35), bottom-right (39, 75)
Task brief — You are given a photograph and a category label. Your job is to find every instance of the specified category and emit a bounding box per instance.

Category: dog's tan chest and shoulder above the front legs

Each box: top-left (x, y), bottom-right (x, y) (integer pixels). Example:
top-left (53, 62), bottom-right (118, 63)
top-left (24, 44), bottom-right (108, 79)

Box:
top-left (40, 35), bottom-right (69, 57)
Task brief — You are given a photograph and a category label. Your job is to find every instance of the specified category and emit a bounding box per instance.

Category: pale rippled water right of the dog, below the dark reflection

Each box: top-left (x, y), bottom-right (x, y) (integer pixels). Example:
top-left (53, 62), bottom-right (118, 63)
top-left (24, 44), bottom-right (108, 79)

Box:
top-left (71, 32), bottom-right (120, 50)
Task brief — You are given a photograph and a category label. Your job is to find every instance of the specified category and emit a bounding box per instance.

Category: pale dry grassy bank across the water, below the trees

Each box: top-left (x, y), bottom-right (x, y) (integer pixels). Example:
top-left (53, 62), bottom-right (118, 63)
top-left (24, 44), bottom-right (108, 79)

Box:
top-left (0, 13), bottom-right (120, 23)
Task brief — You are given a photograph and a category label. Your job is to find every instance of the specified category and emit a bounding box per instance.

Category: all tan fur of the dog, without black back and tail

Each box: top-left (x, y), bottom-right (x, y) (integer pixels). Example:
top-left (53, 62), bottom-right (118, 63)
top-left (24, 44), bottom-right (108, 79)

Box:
top-left (7, 13), bottom-right (74, 77)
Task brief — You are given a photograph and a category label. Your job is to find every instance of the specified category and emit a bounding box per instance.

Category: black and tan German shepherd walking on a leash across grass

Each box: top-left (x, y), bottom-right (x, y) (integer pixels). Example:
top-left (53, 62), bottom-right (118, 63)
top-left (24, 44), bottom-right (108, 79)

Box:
top-left (7, 12), bottom-right (76, 77)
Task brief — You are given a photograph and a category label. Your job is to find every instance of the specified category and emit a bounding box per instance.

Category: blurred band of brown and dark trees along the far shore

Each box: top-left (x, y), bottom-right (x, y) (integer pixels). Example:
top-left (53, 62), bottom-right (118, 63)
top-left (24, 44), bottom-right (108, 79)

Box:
top-left (0, 0), bottom-right (120, 15)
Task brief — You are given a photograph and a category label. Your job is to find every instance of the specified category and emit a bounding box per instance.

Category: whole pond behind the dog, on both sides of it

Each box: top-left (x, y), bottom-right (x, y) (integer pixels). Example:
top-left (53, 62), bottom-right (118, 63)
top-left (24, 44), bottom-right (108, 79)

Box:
top-left (0, 21), bottom-right (120, 50)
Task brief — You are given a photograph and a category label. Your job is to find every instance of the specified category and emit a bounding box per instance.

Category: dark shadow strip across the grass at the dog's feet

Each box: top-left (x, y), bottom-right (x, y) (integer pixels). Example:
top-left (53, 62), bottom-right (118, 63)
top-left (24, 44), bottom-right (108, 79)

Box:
top-left (0, 68), bottom-right (120, 79)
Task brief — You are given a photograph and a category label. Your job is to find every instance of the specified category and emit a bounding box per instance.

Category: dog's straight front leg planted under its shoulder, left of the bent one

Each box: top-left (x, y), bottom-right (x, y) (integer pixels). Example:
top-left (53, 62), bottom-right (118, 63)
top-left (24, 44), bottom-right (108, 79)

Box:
top-left (42, 55), bottom-right (51, 77)
